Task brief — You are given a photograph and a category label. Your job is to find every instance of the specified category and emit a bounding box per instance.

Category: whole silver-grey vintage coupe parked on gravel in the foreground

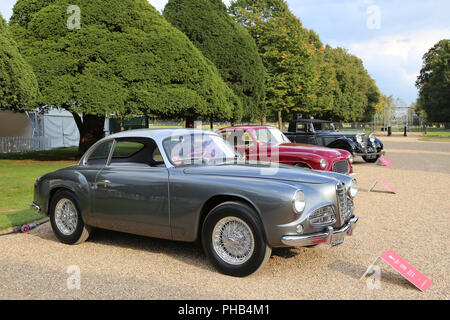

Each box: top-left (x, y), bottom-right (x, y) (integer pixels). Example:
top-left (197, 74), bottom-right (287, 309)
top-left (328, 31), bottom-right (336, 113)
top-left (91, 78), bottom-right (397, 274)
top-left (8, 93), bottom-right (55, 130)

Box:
top-left (31, 129), bottom-right (358, 277)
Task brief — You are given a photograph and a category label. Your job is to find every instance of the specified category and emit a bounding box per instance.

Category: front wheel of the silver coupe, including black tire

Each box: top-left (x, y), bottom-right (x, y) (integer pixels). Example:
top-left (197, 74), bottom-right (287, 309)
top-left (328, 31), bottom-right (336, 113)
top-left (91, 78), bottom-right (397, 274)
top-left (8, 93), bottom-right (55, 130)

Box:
top-left (202, 201), bottom-right (272, 277)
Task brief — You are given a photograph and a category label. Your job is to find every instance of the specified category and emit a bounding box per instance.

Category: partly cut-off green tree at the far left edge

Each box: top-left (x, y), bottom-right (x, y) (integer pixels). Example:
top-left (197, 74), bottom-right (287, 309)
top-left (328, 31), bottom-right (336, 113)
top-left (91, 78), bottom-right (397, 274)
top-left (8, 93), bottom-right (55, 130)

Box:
top-left (0, 16), bottom-right (39, 109)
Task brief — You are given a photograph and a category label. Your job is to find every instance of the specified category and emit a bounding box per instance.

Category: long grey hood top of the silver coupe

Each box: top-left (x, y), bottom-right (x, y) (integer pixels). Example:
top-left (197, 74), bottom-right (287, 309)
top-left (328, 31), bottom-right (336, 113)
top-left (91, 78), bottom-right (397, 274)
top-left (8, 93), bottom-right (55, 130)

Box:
top-left (184, 163), bottom-right (351, 184)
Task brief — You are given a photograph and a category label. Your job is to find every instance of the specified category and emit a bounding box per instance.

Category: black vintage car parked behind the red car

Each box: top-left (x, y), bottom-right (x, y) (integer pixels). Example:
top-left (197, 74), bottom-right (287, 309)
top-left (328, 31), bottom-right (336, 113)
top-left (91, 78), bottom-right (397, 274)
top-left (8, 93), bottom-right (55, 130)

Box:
top-left (284, 119), bottom-right (385, 162)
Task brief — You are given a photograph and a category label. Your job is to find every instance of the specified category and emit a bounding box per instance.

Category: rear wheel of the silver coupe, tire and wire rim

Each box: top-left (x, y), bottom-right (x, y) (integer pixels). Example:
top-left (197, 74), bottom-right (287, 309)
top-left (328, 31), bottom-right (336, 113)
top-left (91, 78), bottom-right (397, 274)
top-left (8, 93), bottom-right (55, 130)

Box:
top-left (49, 190), bottom-right (91, 245)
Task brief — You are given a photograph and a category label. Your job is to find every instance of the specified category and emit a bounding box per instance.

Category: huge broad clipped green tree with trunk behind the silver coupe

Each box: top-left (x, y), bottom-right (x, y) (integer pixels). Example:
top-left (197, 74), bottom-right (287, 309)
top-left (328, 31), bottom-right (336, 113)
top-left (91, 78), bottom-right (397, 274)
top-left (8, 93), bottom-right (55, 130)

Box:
top-left (10, 0), bottom-right (242, 153)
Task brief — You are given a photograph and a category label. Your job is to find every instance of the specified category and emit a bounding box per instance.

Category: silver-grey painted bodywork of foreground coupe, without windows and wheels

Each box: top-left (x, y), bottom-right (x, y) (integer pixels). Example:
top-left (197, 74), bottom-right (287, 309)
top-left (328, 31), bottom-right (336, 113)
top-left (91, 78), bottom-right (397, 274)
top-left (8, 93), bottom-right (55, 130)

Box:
top-left (33, 129), bottom-right (354, 247)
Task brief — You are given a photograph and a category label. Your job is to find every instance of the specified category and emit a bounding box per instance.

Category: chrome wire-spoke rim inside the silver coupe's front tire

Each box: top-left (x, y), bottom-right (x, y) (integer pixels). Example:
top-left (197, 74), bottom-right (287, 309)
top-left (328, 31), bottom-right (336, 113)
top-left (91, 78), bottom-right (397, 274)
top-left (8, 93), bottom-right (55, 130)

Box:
top-left (212, 217), bottom-right (255, 265)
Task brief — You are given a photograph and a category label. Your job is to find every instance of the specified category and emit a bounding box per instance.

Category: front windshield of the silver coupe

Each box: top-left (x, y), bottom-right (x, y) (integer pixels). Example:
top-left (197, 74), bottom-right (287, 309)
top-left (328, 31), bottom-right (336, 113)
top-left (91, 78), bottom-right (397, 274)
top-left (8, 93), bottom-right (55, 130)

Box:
top-left (163, 134), bottom-right (240, 167)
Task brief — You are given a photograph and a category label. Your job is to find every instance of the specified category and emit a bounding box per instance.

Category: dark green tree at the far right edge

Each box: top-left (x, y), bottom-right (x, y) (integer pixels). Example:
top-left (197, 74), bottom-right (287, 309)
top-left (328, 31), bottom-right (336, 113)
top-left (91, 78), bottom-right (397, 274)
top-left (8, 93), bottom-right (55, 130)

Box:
top-left (416, 39), bottom-right (450, 128)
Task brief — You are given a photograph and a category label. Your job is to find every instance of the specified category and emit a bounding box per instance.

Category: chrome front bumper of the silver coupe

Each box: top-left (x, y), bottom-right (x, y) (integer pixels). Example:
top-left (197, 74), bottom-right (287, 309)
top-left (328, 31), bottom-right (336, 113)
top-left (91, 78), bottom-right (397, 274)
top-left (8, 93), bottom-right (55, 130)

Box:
top-left (281, 216), bottom-right (359, 247)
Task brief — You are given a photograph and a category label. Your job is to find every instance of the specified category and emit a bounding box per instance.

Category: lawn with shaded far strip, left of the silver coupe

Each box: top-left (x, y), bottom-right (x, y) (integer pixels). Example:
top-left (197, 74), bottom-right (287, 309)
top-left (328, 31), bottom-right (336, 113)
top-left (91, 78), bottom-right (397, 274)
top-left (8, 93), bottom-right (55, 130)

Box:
top-left (0, 149), bottom-right (77, 230)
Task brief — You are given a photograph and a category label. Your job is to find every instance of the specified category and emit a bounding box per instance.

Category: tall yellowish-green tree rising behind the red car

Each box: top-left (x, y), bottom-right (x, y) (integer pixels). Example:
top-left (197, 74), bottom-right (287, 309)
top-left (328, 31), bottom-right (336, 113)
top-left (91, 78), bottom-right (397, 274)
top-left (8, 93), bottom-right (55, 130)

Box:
top-left (230, 0), bottom-right (323, 126)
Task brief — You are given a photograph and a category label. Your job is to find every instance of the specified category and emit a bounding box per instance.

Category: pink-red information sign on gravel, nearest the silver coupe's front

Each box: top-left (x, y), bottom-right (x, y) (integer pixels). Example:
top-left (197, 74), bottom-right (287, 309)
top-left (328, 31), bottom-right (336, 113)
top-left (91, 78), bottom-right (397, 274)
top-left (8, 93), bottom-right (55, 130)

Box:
top-left (380, 250), bottom-right (432, 292)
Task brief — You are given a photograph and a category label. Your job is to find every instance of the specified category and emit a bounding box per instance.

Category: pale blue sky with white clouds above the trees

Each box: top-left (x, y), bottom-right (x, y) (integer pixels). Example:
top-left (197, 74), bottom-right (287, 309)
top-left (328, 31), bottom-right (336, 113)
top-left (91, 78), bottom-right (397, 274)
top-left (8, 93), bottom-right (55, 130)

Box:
top-left (0, 0), bottom-right (450, 104)
